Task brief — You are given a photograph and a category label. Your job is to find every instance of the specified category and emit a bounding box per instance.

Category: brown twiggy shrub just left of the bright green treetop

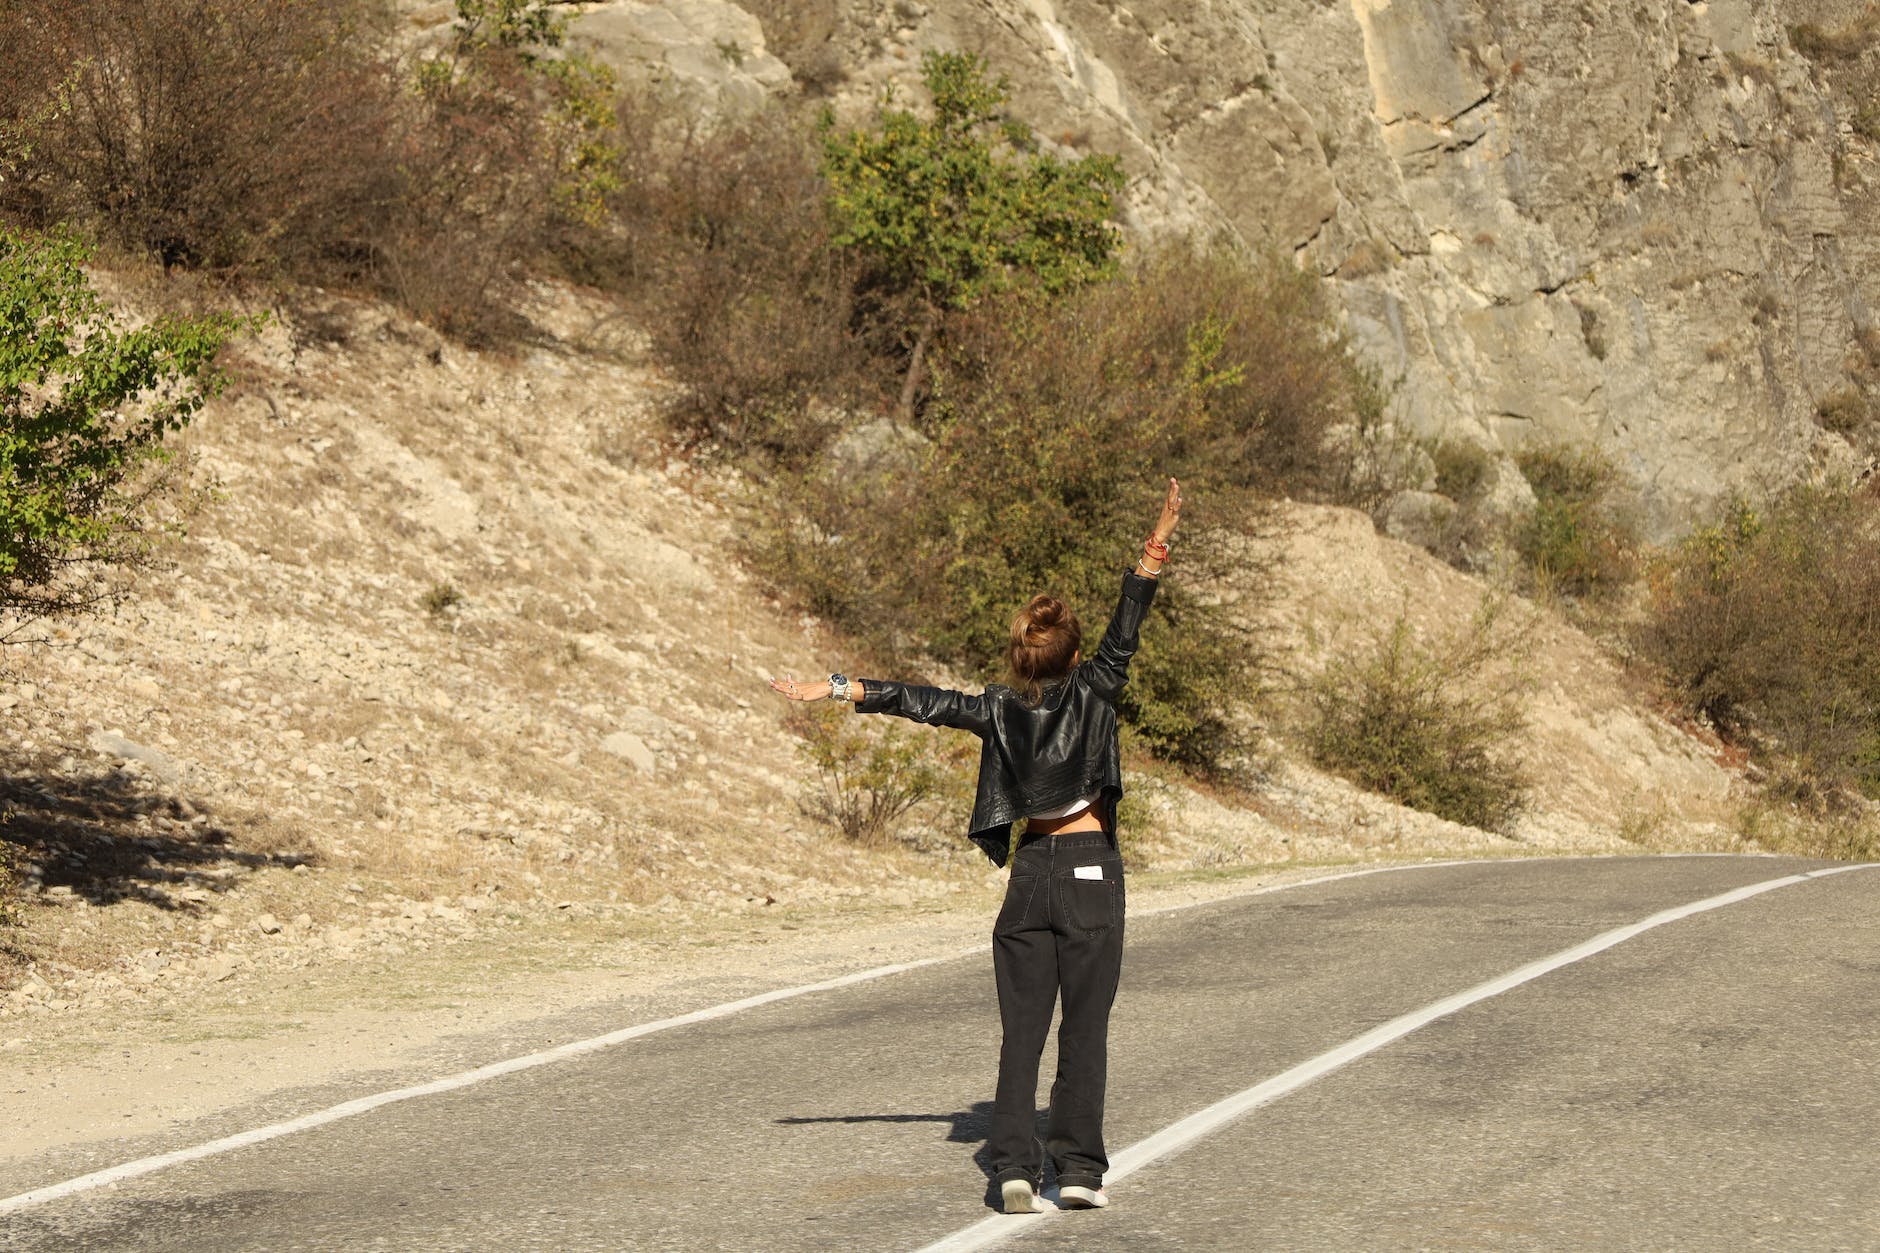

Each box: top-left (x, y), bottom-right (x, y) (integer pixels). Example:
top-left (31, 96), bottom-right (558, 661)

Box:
top-left (609, 103), bottom-right (891, 465)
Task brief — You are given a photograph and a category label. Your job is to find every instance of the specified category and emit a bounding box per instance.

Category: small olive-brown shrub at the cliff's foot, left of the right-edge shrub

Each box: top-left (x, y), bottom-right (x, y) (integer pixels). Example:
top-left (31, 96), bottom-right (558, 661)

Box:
top-left (1515, 444), bottom-right (1639, 596)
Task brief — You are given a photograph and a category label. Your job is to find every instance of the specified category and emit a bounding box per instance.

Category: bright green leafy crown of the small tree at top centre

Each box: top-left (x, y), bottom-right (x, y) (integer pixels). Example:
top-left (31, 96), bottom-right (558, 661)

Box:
top-left (823, 53), bottom-right (1122, 309)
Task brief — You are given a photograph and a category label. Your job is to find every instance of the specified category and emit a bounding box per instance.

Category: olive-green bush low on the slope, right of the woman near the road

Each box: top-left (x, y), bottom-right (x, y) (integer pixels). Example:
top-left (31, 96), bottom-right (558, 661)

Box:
top-left (1308, 600), bottom-right (1528, 832)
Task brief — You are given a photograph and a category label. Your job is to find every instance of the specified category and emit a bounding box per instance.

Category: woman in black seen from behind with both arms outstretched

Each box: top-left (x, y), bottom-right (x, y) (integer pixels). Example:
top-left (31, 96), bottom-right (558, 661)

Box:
top-left (771, 478), bottom-right (1181, 1213)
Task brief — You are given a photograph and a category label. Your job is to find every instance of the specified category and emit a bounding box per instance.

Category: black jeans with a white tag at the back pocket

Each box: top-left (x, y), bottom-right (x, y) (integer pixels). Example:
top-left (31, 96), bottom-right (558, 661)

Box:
top-left (989, 832), bottom-right (1122, 1187)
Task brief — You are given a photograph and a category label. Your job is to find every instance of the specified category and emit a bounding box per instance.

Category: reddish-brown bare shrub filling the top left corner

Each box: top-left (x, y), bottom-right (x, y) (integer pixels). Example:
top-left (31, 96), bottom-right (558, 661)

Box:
top-left (0, 0), bottom-right (397, 277)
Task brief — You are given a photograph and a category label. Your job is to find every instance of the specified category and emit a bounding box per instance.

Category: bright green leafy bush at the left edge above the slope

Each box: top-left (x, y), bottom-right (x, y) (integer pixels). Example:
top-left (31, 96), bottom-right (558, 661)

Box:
top-left (0, 231), bottom-right (248, 617)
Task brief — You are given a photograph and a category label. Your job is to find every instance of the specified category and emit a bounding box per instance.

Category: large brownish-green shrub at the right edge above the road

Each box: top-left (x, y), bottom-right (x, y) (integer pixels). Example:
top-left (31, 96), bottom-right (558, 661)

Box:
top-left (1637, 485), bottom-right (1880, 798)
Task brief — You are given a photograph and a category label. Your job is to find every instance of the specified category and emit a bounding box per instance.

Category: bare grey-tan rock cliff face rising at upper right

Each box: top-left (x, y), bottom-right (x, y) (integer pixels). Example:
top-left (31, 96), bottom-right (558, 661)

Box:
top-left (577, 0), bottom-right (1880, 534)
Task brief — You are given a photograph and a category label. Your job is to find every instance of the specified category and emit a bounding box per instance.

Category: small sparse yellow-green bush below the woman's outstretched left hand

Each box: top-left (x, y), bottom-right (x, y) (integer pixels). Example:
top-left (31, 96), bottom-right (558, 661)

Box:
top-left (790, 706), bottom-right (944, 847)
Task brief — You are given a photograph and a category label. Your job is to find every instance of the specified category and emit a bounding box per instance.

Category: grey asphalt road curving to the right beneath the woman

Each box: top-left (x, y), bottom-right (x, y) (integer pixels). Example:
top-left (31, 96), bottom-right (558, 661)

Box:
top-left (0, 858), bottom-right (1880, 1253)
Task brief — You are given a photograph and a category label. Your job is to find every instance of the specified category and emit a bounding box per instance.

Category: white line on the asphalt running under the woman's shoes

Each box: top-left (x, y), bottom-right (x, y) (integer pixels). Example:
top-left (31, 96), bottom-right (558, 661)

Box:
top-left (919, 864), bottom-right (1872, 1253)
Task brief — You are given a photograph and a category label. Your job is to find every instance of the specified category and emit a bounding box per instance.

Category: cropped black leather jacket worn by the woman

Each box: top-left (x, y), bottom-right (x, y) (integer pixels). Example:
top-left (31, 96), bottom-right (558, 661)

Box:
top-left (857, 572), bottom-right (1156, 865)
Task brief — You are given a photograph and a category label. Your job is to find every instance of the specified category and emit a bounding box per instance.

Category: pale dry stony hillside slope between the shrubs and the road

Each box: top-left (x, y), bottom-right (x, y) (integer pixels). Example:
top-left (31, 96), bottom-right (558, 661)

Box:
top-left (0, 270), bottom-right (1731, 1014)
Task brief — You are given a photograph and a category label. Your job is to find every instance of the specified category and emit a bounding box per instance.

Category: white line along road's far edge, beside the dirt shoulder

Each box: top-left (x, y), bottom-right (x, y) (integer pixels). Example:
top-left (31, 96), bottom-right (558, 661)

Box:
top-left (0, 854), bottom-right (1852, 1211)
